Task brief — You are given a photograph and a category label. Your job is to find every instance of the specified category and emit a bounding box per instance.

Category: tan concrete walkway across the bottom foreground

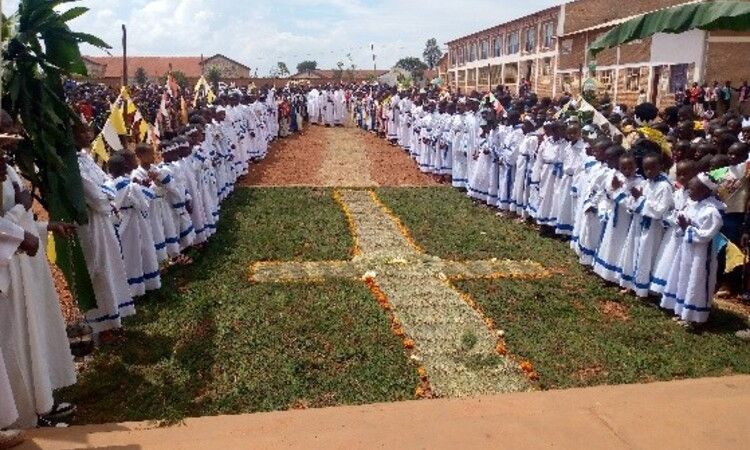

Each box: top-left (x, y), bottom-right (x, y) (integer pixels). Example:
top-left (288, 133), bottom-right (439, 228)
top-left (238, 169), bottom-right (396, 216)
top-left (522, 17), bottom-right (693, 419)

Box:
top-left (19, 376), bottom-right (750, 449)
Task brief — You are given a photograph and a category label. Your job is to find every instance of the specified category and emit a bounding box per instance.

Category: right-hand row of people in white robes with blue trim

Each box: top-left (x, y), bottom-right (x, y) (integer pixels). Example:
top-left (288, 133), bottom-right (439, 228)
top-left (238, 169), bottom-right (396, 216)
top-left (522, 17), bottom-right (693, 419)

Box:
top-left (354, 88), bottom-right (750, 331)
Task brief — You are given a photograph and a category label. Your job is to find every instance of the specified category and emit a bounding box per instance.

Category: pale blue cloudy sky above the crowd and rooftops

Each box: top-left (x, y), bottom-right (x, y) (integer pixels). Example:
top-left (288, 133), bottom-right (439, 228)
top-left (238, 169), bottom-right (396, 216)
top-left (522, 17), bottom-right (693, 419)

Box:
top-left (0, 0), bottom-right (562, 76)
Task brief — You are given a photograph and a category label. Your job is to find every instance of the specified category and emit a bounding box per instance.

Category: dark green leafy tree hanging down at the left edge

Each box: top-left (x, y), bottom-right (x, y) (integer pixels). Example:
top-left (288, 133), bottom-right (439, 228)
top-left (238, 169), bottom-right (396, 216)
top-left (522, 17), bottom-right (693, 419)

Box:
top-left (2, 0), bottom-right (109, 310)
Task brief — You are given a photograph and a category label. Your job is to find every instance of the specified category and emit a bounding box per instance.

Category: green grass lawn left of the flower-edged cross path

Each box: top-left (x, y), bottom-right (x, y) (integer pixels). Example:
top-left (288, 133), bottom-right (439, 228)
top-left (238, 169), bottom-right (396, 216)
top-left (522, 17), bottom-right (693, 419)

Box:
top-left (61, 188), bottom-right (419, 423)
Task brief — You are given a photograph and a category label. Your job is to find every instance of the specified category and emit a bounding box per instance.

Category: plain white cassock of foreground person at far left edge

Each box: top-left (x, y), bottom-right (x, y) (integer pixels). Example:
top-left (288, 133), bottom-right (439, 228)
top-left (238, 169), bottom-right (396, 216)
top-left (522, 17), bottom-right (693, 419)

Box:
top-left (0, 167), bottom-right (76, 428)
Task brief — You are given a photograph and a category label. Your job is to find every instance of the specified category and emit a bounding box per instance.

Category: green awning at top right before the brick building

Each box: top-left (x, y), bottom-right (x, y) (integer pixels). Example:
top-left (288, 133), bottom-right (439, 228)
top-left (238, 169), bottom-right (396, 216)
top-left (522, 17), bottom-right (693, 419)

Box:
top-left (589, 1), bottom-right (750, 56)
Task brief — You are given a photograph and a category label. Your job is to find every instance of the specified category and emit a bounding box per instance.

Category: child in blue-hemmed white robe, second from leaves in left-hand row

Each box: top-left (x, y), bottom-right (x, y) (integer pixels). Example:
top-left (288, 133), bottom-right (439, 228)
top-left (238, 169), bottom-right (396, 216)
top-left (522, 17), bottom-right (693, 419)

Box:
top-left (104, 151), bottom-right (161, 297)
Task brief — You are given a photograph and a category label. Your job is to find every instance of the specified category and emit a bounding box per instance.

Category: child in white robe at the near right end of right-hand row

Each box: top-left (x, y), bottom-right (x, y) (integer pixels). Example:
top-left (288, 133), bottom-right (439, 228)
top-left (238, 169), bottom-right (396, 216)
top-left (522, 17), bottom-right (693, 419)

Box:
top-left (661, 174), bottom-right (724, 325)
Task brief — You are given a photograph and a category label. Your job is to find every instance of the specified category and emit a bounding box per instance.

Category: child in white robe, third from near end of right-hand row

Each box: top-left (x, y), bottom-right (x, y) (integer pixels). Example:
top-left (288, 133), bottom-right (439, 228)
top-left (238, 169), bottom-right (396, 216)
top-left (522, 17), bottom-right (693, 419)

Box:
top-left (620, 154), bottom-right (673, 298)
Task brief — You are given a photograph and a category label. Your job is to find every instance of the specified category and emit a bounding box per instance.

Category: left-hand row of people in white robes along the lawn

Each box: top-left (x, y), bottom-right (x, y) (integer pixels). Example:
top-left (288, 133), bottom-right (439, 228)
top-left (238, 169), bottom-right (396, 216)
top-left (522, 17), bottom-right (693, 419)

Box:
top-left (0, 89), bottom-right (279, 437)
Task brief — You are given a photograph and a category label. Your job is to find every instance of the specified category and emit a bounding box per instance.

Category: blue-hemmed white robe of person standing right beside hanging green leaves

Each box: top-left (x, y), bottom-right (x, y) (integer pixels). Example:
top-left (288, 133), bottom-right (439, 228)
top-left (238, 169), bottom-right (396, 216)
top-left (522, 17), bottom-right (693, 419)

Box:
top-left (78, 151), bottom-right (135, 333)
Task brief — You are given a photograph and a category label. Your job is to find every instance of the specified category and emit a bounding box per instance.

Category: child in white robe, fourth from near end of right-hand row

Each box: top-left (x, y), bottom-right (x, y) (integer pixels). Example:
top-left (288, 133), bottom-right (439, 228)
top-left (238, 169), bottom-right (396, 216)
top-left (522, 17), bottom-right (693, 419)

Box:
top-left (594, 152), bottom-right (643, 283)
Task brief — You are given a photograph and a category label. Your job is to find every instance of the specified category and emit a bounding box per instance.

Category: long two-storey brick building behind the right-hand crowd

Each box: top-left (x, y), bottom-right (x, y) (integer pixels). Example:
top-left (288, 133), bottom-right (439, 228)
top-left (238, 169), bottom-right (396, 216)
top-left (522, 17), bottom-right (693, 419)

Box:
top-left (448, 0), bottom-right (750, 106)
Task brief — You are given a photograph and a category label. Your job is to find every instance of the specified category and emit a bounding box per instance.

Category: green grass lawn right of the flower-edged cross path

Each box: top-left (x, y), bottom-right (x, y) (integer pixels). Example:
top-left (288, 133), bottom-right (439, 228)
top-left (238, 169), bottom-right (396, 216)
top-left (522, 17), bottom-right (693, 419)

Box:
top-left (378, 188), bottom-right (750, 389)
